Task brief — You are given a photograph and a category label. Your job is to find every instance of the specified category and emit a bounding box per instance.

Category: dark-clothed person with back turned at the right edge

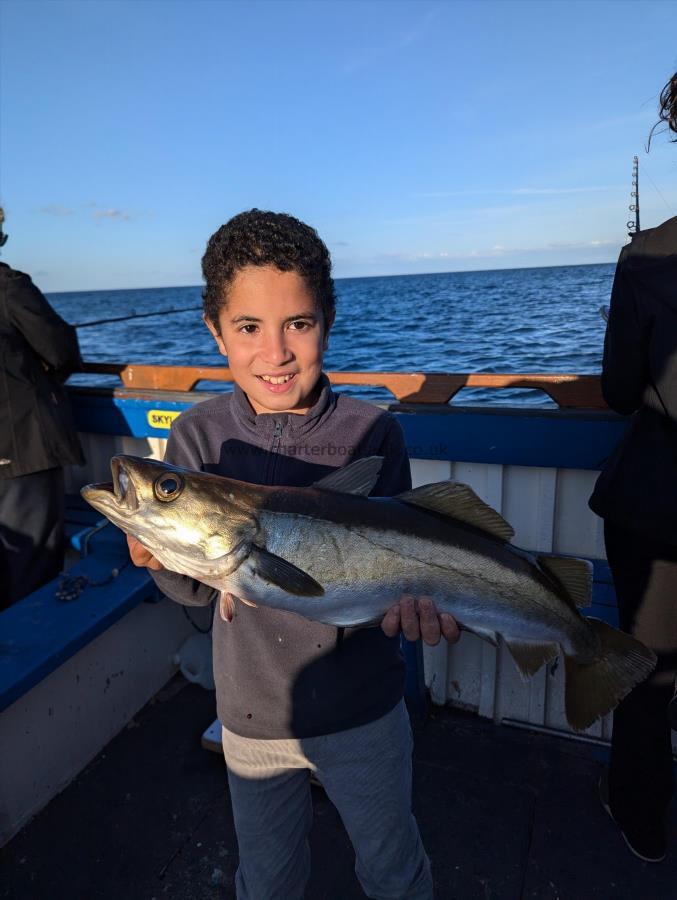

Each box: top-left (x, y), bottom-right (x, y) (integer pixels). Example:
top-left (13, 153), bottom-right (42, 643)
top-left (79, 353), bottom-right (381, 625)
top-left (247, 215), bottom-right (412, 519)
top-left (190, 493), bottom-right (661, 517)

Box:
top-left (590, 73), bottom-right (677, 862)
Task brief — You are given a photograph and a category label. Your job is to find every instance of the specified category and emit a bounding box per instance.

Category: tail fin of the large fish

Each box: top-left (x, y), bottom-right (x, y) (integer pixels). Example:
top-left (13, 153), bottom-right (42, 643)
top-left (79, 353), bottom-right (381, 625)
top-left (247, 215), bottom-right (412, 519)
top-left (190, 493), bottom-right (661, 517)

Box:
top-left (565, 618), bottom-right (656, 731)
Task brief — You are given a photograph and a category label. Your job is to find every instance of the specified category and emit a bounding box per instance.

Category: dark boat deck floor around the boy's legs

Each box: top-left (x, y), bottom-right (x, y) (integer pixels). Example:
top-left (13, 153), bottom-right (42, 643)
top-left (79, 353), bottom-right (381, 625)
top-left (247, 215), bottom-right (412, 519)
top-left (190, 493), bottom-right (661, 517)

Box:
top-left (0, 676), bottom-right (677, 900)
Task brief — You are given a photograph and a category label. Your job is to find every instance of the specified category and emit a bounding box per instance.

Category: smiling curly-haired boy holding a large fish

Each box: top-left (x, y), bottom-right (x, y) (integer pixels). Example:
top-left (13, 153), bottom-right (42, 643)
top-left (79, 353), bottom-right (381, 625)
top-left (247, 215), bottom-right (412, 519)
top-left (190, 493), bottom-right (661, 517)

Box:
top-left (130, 210), bottom-right (458, 900)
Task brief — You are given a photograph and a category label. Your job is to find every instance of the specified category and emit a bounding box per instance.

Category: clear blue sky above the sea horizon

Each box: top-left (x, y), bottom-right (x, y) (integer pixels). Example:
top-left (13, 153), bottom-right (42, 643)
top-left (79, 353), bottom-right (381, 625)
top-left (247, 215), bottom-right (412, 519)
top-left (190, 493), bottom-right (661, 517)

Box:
top-left (0, 0), bottom-right (677, 291)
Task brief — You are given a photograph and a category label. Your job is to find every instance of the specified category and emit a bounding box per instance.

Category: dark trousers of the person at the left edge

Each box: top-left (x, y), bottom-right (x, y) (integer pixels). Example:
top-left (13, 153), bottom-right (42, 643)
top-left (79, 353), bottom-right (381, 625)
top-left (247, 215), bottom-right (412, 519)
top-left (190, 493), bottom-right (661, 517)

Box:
top-left (0, 468), bottom-right (64, 609)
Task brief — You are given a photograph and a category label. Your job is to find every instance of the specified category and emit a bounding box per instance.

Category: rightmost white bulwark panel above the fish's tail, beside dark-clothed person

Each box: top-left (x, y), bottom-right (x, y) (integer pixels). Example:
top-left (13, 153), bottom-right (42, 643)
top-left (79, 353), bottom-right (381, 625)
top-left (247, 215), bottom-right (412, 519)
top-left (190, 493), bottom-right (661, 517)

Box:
top-left (553, 469), bottom-right (606, 559)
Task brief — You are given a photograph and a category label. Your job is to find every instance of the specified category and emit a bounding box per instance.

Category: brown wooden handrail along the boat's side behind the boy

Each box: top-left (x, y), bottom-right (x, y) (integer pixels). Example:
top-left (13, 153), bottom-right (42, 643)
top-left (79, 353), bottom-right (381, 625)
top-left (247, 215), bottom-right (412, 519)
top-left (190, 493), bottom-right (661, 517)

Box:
top-left (84, 362), bottom-right (606, 409)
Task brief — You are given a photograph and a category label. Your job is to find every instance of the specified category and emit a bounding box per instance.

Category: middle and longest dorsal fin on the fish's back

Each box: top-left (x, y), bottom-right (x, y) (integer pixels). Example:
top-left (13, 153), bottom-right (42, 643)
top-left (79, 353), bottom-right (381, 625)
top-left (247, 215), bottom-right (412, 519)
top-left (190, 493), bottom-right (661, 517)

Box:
top-left (397, 481), bottom-right (515, 541)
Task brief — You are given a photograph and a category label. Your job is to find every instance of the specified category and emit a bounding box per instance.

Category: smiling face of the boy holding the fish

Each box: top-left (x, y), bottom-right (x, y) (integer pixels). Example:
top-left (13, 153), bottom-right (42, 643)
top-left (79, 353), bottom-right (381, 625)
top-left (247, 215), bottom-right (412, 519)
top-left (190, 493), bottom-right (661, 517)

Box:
top-left (205, 266), bottom-right (331, 413)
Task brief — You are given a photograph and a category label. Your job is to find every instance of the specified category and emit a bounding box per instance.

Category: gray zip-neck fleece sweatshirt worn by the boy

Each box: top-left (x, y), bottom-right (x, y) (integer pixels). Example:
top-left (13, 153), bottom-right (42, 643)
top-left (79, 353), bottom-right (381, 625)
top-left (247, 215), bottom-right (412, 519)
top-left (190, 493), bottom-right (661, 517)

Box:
top-left (151, 376), bottom-right (411, 739)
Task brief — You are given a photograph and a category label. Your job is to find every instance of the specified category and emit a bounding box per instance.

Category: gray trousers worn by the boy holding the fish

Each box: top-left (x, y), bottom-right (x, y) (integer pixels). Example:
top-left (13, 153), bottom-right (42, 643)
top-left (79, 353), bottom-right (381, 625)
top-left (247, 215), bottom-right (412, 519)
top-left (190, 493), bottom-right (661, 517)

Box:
top-left (223, 702), bottom-right (433, 900)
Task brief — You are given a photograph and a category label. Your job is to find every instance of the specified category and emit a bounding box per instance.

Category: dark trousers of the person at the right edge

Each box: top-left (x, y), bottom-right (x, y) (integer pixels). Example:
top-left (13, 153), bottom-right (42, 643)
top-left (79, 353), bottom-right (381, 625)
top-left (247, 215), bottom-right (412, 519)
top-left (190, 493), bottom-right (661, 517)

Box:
top-left (604, 522), bottom-right (677, 830)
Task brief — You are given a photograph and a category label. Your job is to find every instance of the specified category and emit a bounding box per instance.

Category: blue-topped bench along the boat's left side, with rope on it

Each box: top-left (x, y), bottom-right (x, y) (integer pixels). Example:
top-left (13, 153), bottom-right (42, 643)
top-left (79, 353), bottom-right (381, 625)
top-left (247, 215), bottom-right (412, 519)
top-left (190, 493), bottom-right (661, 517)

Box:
top-left (0, 498), bottom-right (158, 712)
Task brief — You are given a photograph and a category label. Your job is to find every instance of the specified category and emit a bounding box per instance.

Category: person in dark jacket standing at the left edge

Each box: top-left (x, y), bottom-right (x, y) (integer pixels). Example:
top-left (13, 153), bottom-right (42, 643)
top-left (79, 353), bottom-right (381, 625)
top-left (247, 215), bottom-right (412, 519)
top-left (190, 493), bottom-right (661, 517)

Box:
top-left (0, 210), bottom-right (83, 609)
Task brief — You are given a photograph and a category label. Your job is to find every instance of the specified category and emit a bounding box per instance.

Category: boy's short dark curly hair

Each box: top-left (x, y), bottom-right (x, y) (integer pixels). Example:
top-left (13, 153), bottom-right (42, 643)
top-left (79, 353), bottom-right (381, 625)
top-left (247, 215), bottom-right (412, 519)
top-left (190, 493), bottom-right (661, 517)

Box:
top-left (202, 209), bottom-right (336, 330)
